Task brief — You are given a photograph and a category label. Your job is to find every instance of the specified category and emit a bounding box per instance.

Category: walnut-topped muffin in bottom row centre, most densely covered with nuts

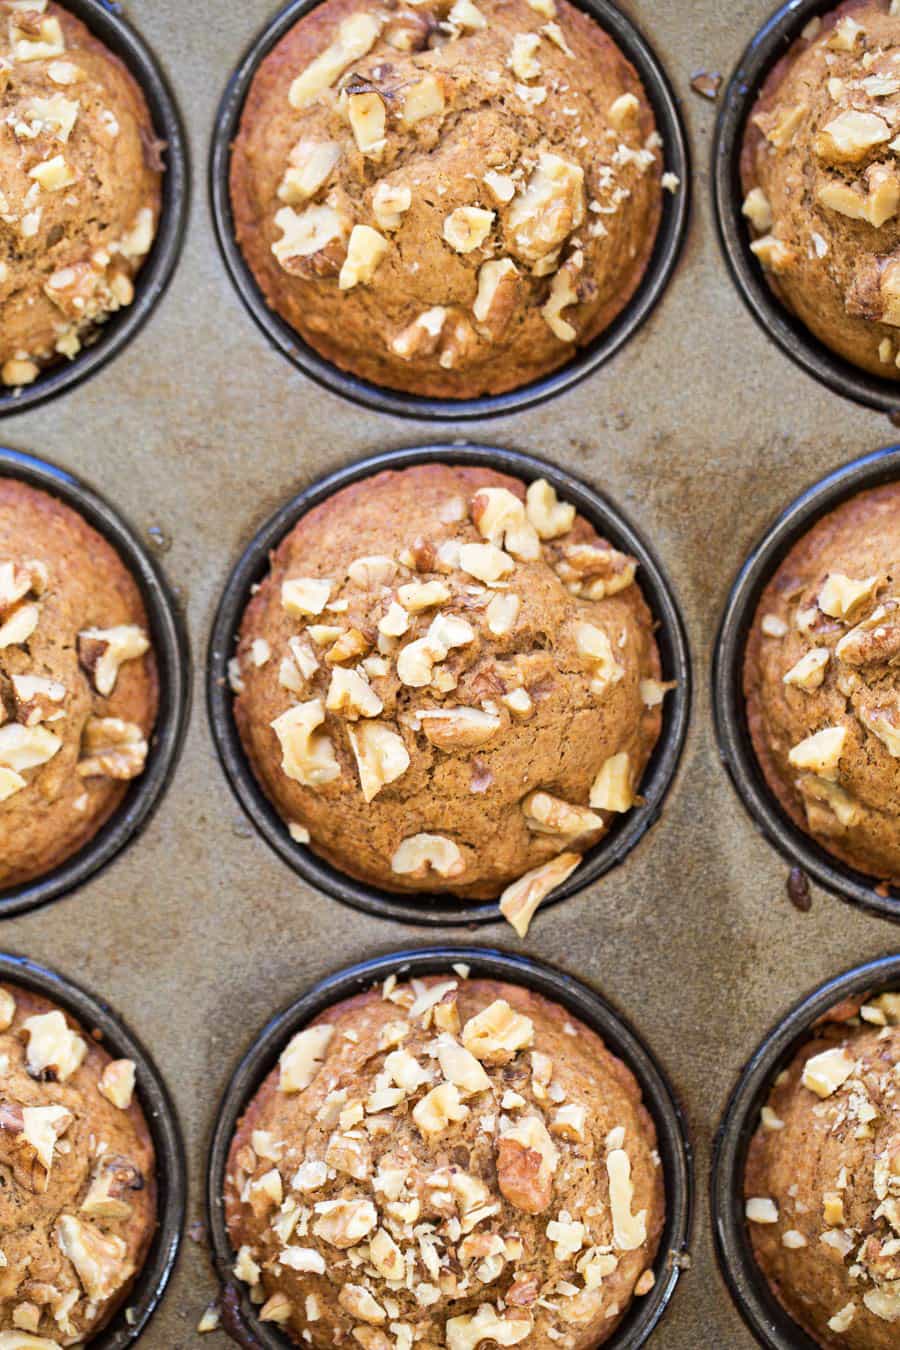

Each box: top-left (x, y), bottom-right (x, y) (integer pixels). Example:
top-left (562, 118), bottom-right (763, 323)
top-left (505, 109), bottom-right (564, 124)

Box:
top-left (225, 968), bottom-right (664, 1350)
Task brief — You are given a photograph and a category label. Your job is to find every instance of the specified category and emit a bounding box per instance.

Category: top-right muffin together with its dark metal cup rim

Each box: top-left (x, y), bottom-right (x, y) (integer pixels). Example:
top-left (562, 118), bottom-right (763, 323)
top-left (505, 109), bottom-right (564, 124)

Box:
top-left (714, 0), bottom-right (900, 412)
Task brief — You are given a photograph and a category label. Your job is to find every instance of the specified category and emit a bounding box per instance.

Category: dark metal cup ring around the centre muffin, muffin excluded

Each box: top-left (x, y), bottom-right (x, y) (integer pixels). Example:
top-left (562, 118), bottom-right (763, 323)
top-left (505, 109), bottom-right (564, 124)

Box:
top-left (206, 444), bottom-right (691, 926)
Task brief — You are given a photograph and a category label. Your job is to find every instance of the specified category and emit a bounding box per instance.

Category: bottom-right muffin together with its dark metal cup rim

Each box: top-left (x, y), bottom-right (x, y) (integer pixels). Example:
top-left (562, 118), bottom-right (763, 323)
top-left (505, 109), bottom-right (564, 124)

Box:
top-left (711, 956), bottom-right (900, 1350)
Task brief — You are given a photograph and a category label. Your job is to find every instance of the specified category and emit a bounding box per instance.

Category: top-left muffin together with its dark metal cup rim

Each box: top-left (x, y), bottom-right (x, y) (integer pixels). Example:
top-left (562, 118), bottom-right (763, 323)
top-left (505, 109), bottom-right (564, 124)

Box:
top-left (0, 0), bottom-right (188, 414)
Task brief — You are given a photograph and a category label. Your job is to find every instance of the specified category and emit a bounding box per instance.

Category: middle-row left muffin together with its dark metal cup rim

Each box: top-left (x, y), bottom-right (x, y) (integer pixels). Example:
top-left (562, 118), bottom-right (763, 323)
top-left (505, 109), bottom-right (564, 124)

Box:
top-left (0, 451), bottom-right (188, 914)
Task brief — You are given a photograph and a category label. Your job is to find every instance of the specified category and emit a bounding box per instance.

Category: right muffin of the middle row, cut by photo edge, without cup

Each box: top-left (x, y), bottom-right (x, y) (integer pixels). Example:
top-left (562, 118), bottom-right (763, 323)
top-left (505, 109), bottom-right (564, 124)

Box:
top-left (743, 483), bottom-right (900, 883)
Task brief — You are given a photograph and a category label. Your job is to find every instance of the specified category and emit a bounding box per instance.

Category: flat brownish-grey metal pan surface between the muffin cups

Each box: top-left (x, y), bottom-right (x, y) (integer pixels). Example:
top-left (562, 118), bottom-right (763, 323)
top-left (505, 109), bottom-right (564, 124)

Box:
top-left (0, 0), bottom-right (897, 1350)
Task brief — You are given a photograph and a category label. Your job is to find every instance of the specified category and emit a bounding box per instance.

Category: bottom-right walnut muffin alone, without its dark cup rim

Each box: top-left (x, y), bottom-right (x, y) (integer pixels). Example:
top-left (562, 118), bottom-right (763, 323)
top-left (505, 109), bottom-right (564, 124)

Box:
top-left (745, 994), bottom-right (900, 1350)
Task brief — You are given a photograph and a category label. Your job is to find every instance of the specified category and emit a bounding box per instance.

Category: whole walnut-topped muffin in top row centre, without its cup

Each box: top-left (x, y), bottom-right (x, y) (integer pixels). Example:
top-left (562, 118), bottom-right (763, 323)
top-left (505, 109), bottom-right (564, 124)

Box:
top-left (231, 0), bottom-right (666, 398)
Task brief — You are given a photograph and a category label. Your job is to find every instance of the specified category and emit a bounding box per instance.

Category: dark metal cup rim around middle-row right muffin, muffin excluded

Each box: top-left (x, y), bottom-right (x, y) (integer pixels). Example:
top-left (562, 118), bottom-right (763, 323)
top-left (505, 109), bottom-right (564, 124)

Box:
top-left (712, 446), bottom-right (900, 922)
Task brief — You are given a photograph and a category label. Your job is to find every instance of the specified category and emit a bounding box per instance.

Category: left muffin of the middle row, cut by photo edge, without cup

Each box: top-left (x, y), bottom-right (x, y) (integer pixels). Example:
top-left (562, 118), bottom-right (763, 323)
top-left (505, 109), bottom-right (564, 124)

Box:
top-left (0, 478), bottom-right (158, 891)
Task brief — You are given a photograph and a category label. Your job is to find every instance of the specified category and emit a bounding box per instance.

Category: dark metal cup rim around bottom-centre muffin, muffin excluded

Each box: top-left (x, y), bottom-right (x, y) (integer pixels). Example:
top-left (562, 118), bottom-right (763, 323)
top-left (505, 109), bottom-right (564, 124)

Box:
top-left (206, 946), bottom-right (694, 1350)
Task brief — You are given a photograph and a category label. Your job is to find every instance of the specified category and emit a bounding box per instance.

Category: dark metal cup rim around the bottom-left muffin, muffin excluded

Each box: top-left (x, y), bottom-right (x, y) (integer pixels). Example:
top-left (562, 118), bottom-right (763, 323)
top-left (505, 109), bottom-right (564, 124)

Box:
top-left (0, 953), bottom-right (188, 1350)
